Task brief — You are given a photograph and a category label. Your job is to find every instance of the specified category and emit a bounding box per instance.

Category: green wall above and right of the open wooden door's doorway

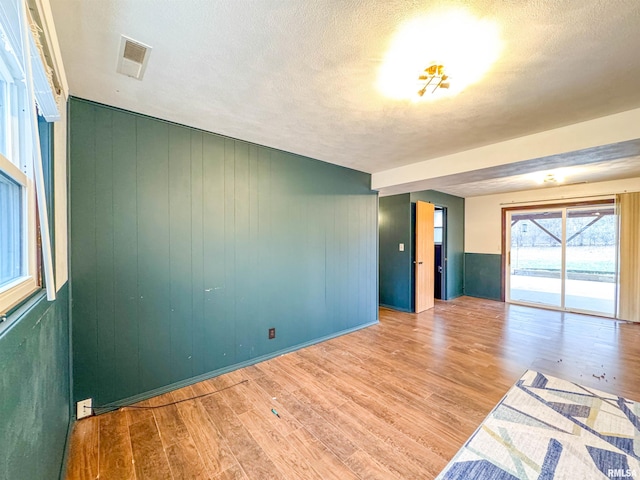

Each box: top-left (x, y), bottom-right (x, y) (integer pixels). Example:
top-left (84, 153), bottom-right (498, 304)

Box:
top-left (411, 190), bottom-right (464, 300)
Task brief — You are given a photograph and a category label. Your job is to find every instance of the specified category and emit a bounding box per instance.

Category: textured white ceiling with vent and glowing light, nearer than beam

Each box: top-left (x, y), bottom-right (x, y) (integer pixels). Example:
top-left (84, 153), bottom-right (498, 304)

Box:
top-left (50, 0), bottom-right (640, 193)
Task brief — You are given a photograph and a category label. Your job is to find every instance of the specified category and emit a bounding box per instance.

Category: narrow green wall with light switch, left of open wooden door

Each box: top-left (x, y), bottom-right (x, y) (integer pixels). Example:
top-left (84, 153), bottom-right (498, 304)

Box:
top-left (379, 193), bottom-right (413, 312)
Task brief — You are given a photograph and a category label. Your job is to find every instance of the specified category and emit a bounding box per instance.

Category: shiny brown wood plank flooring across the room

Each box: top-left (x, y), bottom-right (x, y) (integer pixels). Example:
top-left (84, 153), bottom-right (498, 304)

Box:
top-left (66, 297), bottom-right (640, 480)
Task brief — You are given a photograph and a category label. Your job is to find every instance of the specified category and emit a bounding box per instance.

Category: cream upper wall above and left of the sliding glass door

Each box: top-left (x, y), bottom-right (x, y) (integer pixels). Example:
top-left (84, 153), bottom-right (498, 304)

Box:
top-left (464, 174), bottom-right (640, 254)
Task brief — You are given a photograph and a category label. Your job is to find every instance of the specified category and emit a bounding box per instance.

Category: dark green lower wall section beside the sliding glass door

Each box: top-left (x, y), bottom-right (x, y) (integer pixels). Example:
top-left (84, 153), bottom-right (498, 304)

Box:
top-left (464, 253), bottom-right (502, 300)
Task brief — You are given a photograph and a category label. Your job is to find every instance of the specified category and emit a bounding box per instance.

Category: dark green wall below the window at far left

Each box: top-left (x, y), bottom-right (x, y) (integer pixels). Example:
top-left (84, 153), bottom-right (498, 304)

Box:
top-left (0, 286), bottom-right (71, 480)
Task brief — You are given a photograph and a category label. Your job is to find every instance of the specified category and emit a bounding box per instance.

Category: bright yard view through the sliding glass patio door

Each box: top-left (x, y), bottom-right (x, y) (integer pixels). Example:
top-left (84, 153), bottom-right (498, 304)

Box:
top-left (505, 203), bottom-right (618, 317)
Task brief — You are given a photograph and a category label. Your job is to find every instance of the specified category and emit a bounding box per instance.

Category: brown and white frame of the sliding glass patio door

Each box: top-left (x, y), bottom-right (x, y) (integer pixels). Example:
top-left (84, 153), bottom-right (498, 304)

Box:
top-left (500, 198), bottom-right (619, 318)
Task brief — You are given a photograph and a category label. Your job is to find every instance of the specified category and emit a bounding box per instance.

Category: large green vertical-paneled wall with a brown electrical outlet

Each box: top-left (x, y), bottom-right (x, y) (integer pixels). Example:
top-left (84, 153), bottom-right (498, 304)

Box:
top-left (70, 99), bottom-right (377, 404)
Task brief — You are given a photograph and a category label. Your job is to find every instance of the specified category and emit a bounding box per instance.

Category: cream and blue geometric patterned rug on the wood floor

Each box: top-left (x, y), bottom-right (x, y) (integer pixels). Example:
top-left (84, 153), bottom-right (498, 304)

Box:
top-left (436, 370), bottom-right (640, 480)
